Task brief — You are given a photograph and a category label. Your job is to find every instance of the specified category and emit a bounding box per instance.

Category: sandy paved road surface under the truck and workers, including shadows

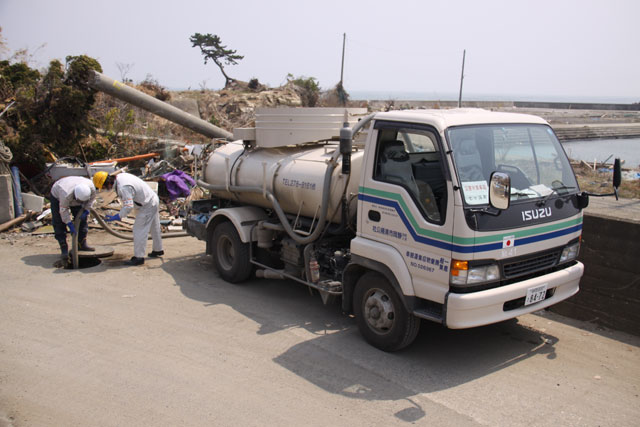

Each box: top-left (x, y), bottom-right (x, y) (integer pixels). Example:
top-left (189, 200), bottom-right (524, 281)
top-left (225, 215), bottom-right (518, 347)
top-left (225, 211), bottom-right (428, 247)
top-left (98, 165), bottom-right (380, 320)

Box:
top-left (0, 231), bottom-right (640, 426)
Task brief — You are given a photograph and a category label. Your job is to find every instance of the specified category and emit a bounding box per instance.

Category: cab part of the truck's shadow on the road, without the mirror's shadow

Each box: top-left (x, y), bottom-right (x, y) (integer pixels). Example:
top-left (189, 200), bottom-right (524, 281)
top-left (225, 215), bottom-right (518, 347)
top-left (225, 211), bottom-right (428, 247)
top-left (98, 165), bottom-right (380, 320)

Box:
top-left (274, 320), bottom-right (557, 400)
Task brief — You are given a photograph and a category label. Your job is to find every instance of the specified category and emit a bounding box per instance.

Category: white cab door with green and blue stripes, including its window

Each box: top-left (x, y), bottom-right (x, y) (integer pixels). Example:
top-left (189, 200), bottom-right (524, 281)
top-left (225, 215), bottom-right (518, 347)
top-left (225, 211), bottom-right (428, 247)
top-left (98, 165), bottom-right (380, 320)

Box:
top-left (358, 121), bottom-right (453, 303)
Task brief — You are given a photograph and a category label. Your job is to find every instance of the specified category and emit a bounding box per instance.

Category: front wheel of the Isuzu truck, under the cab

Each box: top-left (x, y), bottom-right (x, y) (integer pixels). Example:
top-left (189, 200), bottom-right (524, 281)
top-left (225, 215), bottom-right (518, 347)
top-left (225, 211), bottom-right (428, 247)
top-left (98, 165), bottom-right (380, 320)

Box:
top-left (353, 272), bottom-right (420, 351)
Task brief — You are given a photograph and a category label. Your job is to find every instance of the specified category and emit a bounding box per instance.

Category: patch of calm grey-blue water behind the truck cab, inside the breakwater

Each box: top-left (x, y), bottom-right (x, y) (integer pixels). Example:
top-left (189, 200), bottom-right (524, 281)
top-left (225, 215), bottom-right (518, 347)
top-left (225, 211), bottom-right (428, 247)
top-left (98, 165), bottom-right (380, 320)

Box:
top-left (562, 138), bottom-right (640, 170)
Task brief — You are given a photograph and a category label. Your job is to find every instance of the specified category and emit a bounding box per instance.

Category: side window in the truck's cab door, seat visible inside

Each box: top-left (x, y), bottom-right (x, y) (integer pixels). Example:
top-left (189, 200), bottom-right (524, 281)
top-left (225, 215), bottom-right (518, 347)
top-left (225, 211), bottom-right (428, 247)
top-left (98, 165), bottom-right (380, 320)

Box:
top-left (373, 127), bottom-right (447, 224)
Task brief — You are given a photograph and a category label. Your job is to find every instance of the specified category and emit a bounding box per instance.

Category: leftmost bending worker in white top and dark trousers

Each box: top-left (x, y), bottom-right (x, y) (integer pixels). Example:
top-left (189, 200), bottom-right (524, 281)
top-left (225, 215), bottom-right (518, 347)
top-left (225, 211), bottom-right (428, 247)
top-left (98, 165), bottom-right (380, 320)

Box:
top-left (49, 176), bottom-right (96, 259)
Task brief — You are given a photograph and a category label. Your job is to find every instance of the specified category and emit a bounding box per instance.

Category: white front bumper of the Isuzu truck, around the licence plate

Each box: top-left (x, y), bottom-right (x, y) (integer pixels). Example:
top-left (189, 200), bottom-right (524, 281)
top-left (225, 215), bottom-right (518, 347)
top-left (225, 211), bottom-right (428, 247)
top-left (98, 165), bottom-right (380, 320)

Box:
top-left (445, 262), bottom-right (584, 329)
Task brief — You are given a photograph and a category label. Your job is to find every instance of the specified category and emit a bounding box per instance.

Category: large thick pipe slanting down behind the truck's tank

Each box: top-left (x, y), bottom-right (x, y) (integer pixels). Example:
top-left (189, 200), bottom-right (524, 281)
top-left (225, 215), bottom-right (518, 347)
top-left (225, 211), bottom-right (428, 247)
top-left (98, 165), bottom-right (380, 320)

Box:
top-left (87, 71), bottom-right (233, 140)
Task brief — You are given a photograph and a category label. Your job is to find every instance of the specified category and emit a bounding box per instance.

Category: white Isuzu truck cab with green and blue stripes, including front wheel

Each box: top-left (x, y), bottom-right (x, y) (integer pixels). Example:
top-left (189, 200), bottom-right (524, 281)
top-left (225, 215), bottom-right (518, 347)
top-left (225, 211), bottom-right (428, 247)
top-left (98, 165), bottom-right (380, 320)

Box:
top-left (345, 109), bottom-right (583, 349)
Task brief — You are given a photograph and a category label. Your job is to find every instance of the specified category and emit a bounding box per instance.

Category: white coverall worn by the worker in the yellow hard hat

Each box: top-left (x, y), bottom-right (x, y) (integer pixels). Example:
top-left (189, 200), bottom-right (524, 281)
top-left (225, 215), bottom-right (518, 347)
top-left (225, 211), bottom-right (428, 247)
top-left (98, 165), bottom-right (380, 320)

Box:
top-left (115, 173), bottom-right (162, 258)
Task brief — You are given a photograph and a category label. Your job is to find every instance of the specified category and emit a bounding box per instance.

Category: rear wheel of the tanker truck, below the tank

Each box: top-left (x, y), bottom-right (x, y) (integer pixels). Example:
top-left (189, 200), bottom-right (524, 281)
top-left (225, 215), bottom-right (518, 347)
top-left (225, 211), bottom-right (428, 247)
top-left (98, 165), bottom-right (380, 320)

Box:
top-left (211, 222), bottom-right (253, 283)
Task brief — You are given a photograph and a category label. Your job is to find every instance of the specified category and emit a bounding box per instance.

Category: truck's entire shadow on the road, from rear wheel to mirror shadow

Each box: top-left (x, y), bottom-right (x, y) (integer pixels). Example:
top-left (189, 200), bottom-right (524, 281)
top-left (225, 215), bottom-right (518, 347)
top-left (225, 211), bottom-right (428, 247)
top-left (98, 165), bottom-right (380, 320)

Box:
top-left (162, 255), bottom-right (558, 414)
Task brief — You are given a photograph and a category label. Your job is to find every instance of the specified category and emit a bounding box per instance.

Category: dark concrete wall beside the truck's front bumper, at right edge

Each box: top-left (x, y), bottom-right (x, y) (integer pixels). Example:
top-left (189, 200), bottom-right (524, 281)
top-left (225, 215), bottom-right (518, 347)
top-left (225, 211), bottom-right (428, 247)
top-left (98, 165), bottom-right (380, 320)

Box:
top-left (551, 198), bottom-right (640, 336)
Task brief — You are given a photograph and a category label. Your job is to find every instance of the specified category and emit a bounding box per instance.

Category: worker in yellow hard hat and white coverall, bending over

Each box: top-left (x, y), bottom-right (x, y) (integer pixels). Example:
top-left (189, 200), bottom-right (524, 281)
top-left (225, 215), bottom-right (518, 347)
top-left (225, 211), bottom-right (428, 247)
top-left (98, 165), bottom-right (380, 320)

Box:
top-left (93, 171), bottom-right (164, 265)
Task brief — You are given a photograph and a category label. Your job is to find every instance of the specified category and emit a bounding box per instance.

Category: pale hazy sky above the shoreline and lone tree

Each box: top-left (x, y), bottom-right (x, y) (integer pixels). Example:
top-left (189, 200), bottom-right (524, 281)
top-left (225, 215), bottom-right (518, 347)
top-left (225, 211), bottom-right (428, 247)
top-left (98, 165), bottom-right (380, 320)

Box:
top-left (0, 0), bottom-right (640, 102)
